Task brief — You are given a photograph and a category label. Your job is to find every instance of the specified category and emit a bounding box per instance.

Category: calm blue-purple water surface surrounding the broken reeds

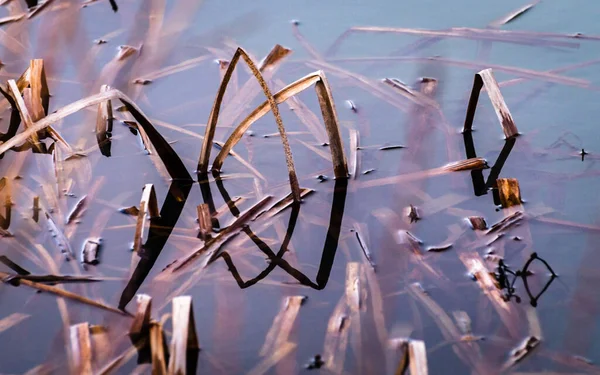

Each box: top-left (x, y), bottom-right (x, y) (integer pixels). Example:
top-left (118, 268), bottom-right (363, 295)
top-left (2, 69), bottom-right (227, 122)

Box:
top-left (0, 1), bottom-right (600, 374)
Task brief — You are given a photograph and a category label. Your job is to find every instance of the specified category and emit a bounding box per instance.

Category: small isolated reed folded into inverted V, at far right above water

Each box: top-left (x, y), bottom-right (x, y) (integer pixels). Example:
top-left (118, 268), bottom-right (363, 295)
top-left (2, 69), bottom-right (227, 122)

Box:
top-left (463, 69), bottom-right (519, 138)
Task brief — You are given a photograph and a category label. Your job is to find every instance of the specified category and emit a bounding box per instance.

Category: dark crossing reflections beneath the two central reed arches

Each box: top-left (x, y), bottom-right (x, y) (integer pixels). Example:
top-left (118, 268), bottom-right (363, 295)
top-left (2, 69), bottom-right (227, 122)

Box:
top-left (203, 174), bottom-right (348, 290)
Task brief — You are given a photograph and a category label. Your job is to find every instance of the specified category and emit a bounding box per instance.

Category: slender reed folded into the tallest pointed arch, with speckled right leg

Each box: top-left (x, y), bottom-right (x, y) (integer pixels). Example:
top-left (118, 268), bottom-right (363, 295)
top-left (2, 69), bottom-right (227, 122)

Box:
top-left (198, 48), bottom-right (300, 202)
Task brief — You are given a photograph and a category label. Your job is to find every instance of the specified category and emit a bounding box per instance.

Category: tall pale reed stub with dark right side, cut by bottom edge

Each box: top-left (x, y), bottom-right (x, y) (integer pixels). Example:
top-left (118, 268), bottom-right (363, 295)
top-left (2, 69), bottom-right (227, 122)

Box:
top-left (167, 296), bottom-right (200, 375)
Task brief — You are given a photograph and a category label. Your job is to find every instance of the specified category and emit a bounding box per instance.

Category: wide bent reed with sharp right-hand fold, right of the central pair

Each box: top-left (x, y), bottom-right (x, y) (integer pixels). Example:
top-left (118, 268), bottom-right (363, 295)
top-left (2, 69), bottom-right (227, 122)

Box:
top-left (213, 70), bottom-right (348, 178)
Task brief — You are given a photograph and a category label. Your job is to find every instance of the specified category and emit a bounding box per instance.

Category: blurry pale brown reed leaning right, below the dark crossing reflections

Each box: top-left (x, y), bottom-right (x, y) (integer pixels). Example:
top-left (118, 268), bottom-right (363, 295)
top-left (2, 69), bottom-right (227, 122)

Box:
top-left (259, 296), bottom-right (306, 357)
